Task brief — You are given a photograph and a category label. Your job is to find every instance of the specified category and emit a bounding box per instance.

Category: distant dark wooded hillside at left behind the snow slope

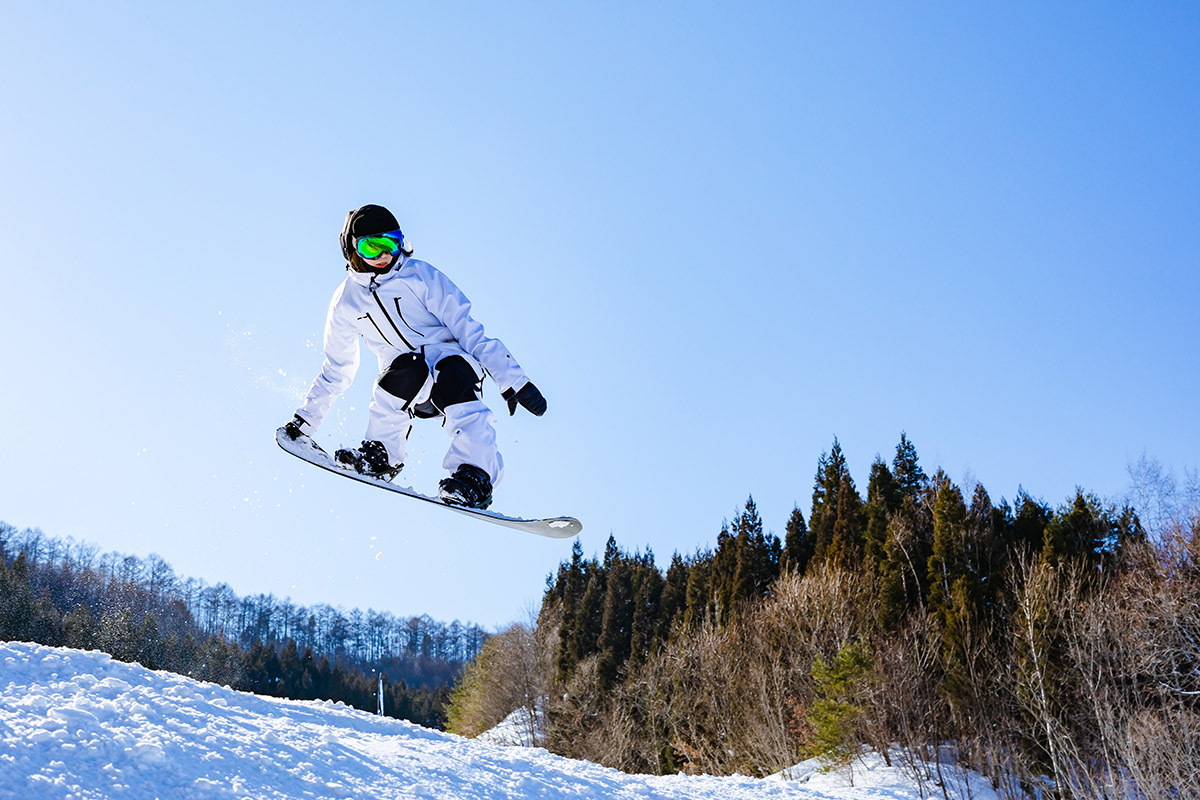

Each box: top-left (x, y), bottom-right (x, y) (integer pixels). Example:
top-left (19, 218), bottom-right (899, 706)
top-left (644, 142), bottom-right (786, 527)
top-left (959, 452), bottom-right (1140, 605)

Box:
top-left (0, 523), bottom-right (486, 727)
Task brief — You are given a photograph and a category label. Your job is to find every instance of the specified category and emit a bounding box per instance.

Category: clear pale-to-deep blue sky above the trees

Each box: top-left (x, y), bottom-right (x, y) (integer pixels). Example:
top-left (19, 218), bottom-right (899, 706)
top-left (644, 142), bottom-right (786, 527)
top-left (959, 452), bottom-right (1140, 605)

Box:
top-left (0, 2), bottom-right (1200, 625)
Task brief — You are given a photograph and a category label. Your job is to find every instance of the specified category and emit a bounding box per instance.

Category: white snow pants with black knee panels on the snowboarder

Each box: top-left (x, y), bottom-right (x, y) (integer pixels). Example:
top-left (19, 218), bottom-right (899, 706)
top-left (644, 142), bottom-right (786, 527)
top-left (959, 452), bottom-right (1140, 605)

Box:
top-left (365, 355), bottom-right (504, 488)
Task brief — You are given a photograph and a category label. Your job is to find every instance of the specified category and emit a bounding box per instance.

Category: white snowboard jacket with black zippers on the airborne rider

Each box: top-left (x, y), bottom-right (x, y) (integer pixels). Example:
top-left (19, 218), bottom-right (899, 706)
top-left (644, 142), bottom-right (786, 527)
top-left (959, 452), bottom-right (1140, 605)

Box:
top-left (296, 255), bottom-right (528, 433)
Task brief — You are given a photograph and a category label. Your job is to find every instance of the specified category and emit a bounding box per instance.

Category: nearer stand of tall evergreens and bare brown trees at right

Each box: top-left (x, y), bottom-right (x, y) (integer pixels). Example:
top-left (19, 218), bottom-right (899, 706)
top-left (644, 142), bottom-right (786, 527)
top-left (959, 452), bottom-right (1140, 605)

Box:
top-left (450, 435), bottom-right (1200, 798)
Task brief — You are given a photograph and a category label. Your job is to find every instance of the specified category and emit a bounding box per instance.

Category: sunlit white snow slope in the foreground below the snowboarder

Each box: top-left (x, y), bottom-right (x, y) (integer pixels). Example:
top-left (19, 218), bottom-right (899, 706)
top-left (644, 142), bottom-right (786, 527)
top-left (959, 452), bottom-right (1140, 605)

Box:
top-left (0, 642), bottom-right (995, 800)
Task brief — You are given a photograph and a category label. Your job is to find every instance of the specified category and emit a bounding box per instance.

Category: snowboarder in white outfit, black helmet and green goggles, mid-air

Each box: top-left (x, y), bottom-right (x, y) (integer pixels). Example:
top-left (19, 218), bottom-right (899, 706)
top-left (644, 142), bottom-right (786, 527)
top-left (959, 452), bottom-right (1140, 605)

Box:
top-left (286, 205), bottom-right (546, 509)
